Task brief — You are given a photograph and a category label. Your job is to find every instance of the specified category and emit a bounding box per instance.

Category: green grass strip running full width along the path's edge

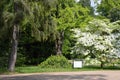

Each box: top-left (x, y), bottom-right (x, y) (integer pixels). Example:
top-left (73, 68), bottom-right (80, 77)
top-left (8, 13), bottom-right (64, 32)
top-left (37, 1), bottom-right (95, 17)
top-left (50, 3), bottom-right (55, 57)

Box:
top-left (0, 66), bottom-right (120, 74)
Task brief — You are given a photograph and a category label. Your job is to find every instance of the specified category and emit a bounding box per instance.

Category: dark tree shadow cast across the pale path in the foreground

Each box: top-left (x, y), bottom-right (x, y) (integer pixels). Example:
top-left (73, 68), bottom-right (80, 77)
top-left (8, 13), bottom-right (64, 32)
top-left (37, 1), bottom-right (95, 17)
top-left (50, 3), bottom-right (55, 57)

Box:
top-left (0, 74), bottom-right (107, 80)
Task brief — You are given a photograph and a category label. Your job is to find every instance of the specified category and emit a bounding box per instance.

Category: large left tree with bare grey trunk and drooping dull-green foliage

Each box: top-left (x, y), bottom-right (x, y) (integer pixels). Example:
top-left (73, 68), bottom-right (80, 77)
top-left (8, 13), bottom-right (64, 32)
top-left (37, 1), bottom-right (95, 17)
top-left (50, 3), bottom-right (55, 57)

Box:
top-left (1, 0), bottom-right (54, 71)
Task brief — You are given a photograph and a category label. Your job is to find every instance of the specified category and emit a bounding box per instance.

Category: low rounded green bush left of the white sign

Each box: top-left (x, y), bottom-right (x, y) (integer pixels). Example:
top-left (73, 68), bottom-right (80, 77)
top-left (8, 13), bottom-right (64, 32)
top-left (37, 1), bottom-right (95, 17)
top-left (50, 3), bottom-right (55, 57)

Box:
top-left (39, 56), bottom-right (71, 68)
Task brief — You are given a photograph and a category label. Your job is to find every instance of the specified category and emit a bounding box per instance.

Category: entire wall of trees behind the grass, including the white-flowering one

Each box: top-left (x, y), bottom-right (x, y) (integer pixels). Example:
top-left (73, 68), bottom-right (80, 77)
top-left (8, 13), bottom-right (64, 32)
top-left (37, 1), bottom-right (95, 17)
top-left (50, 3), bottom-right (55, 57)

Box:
top-left (0, 0), bottom-right (120, 71)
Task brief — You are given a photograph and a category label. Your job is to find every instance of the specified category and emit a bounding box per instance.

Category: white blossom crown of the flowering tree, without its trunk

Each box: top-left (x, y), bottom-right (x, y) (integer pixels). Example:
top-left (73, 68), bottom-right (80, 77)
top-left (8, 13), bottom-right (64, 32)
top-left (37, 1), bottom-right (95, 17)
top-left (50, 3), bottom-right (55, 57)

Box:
top-left (73, 21), bottom-right (120, 57)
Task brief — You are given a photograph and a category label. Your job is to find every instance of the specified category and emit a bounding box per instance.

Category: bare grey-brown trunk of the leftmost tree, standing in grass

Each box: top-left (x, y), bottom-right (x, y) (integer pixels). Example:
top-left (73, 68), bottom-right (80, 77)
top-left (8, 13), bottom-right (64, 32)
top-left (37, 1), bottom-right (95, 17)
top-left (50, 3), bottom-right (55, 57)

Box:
top-left (8, 25), bottom-right (19, 72)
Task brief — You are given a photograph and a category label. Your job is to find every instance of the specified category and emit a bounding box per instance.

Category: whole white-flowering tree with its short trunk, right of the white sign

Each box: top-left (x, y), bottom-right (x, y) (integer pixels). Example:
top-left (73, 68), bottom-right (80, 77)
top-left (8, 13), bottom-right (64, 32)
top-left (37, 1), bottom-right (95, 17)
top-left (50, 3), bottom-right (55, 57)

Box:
top-left (71, 19), bottom-right (120, 67)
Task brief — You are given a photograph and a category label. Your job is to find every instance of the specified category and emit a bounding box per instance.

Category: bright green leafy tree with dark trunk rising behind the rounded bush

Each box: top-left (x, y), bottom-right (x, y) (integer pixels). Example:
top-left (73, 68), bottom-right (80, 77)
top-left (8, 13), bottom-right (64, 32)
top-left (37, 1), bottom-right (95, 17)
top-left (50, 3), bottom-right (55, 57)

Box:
top-left (54, 0), bottom-right (89, 55)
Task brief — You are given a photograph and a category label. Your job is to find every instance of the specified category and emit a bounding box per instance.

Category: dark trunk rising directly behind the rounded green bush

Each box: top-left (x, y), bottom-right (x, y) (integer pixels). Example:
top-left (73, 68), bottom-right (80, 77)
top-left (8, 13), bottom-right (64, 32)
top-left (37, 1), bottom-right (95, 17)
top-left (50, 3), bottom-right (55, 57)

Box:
top-left (55, 31), bottom-right (64, 55)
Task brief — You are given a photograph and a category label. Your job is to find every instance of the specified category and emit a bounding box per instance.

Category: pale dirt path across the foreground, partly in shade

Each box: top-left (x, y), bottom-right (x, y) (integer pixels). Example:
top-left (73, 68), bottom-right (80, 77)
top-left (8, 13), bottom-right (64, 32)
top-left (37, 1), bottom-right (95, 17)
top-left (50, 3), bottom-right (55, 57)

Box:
top-left (0, 71), bottom-right (120, 80)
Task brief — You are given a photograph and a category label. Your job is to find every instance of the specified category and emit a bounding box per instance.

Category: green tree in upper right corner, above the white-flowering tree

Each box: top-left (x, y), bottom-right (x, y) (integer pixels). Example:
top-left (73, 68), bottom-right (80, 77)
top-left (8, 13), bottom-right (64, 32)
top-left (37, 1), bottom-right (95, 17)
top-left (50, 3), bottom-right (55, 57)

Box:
top-left (97, 0), bottom-right (120, 22)
